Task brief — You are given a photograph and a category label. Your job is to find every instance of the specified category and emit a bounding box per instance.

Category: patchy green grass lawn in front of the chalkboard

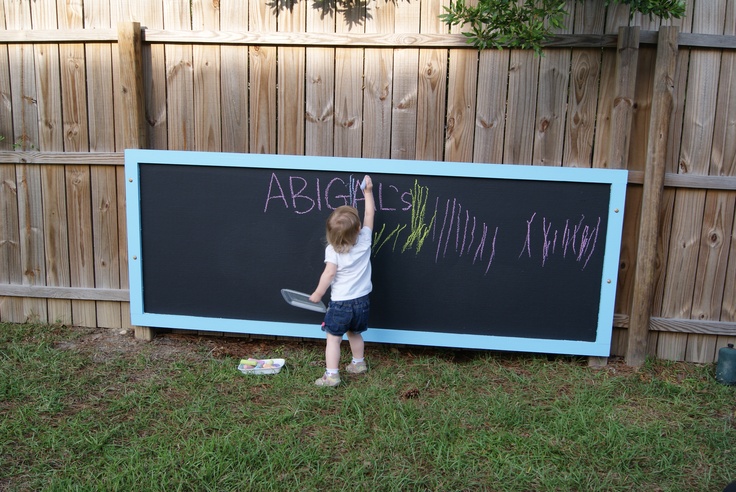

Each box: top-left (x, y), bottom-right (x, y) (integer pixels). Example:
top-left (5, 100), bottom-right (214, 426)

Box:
top-left (0, 324), bottom-right (736, 491)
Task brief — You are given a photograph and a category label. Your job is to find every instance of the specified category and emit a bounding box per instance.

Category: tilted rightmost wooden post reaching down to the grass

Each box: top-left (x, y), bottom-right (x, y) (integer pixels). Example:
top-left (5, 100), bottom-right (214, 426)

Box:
top-left (626, 26), bottom-right (679, 367)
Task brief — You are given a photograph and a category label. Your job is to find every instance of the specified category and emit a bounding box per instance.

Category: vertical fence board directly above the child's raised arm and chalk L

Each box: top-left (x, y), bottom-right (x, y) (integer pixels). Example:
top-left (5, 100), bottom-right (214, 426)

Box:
top-left (362, 0), bottom-right (395, 159)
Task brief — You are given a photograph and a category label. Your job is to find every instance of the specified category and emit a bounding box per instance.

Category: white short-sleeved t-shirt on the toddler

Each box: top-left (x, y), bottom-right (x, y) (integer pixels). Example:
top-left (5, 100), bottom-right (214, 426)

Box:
top-left (325, 227), bottom-right (373, 301)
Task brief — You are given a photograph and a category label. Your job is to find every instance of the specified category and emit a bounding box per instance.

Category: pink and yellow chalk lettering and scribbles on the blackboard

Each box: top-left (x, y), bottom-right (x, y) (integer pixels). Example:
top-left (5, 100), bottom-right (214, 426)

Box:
top-left (263, 172), bottom-right (601, 274)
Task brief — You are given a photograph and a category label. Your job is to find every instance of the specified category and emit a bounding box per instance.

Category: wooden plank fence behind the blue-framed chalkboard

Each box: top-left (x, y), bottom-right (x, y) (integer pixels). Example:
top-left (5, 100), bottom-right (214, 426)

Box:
top-left (0, 0), bottom-right (736, 365)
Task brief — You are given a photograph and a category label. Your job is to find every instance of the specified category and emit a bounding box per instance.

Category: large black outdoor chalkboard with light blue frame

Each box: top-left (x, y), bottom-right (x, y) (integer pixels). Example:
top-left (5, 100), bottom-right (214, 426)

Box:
top-left (125, 150), bottom-right (626, 355)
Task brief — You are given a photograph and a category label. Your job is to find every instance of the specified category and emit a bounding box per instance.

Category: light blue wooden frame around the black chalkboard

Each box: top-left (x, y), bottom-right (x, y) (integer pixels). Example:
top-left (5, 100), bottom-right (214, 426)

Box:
top-left (125, 149), bottom-right (628, 357)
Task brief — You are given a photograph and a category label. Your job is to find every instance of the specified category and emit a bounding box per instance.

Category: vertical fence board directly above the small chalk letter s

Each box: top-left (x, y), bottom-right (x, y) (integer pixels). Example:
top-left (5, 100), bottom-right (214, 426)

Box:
top-left (391, 1), bottom-right (421, 159)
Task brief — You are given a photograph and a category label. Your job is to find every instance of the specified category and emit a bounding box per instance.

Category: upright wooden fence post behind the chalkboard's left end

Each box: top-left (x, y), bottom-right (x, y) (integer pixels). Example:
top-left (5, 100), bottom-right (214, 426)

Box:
top-left (115, 22), bottom-right (153, 341)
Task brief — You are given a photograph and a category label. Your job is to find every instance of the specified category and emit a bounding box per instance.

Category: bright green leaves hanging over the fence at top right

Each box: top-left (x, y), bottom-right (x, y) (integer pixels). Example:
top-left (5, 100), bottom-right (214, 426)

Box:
top-left (440, 0), bottom-right (685, 55)
